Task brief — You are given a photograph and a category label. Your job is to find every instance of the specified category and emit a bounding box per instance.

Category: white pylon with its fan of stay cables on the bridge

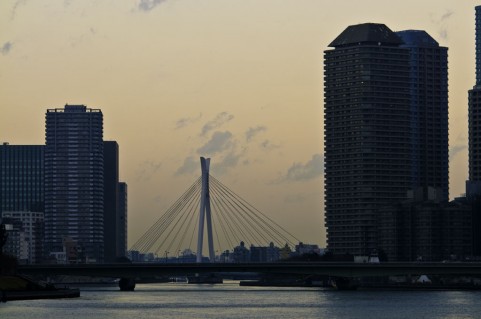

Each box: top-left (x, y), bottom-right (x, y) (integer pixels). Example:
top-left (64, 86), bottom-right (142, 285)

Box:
top-left (130, 157), bottom-right (299, 262)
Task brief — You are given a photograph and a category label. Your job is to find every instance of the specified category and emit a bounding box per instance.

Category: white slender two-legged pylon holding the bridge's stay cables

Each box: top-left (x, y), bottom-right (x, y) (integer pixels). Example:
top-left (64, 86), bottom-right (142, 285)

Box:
top-left (196, 157), bottom-right (215, 263)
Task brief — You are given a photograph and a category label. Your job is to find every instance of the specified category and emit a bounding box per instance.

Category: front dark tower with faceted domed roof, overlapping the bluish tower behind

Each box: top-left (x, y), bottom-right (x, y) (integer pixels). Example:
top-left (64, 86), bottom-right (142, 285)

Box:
top-left (324, 23), bottom-right (412, 255)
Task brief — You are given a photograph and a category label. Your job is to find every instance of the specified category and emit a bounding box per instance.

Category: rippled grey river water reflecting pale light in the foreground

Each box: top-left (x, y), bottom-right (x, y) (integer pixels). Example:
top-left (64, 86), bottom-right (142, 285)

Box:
top-left (0, 282), bottom-right (481, 319)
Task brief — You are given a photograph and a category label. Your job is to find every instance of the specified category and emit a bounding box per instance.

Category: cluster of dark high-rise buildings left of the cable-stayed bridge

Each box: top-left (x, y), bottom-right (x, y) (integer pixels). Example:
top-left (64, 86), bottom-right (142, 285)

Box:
top-left (0, 105), bottom-right (127, 263)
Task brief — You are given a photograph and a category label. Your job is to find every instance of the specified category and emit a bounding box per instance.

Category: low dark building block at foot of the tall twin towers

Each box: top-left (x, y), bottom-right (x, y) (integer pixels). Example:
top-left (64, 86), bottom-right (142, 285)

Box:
top-left (378, 196), bottom-right (473, 261)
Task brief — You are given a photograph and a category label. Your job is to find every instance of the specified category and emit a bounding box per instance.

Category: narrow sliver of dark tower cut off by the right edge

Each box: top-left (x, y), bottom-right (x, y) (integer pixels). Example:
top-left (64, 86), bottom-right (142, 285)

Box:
top-left (466, 6), bottom-right (481, 196)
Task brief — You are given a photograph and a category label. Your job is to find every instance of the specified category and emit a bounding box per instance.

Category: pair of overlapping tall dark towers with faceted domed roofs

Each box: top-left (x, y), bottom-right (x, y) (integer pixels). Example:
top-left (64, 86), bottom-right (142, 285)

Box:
top-left (324, 23), bottom-right (448, 255)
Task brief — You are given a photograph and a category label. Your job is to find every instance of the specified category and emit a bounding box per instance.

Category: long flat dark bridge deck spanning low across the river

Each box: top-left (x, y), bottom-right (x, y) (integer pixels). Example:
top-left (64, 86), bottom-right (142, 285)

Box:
top-left (18, 262), bottom-right (481, 278)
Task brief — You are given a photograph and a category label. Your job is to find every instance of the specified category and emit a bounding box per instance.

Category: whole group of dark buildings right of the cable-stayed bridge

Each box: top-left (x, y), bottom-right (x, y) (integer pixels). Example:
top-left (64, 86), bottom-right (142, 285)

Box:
top-left (324, 11), bottom-right (481, 261)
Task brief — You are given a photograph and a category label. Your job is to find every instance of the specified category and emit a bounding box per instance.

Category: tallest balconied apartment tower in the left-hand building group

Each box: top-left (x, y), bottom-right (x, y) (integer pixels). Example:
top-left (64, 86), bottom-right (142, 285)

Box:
top-left (45, 105), bottom-right (104, 262)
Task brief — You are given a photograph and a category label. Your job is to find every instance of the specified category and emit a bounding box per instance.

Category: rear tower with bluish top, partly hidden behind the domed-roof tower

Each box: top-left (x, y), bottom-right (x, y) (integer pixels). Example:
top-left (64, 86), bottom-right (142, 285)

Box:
top-left (396, 30), bottom-right (449, 201)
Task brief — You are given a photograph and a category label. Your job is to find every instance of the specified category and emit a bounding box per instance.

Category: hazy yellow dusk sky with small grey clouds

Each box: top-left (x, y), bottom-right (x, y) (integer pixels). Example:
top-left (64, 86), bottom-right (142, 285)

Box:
top-left (0, 0), bottom-right (481, 247)
